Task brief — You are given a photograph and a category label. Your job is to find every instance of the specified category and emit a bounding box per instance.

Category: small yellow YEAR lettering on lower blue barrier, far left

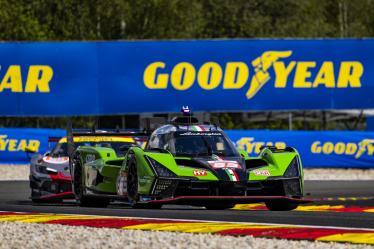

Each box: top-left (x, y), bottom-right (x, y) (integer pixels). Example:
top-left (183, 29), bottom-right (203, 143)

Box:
top-left (0, 134), bottom-right (40, 152)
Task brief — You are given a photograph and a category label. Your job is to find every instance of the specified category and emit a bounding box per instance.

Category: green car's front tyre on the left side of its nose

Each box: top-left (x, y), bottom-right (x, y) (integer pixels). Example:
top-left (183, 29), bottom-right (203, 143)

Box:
top-left (127, 154), bottom-right (162, 209)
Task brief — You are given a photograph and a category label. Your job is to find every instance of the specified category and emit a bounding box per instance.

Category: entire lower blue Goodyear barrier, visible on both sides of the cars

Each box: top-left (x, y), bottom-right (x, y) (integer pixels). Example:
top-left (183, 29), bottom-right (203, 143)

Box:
top-left (0, 128), bottom-right (374, 168)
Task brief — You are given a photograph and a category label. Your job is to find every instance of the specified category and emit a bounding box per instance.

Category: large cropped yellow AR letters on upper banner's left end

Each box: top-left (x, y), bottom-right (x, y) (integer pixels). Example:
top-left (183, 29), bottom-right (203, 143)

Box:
top-left (0, 65), bottom-right (53, 93)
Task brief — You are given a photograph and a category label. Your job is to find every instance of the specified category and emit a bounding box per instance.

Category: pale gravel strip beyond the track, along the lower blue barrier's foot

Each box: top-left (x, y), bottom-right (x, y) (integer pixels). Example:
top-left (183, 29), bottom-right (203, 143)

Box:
top-left (0, 164), bottom-right (374, 180)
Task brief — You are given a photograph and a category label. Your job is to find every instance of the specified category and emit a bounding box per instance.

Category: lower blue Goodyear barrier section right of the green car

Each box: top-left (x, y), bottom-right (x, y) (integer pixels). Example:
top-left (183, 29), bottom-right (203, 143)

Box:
top-left (227, 130), bottom-right (374, 168)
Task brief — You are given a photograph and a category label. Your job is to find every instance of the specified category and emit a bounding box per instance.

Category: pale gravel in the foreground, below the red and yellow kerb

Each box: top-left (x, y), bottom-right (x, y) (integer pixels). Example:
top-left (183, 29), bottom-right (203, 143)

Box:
top-left (0, 222), bottom-right (372, 249)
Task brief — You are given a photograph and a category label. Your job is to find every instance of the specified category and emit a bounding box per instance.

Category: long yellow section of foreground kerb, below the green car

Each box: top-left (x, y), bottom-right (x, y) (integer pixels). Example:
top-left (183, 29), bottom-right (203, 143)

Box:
top-left (123, 222), bottom-right (285, 233)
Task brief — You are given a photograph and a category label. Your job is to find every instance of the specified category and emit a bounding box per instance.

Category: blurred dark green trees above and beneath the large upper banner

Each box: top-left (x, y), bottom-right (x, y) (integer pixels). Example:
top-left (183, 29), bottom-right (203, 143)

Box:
top-left (0, 0), bottom-right (374, 129)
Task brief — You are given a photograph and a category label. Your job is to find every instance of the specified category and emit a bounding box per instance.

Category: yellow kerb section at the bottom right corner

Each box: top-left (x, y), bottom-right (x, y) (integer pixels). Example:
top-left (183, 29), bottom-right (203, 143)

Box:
top-left (316, 233), bottom-right (374, 244)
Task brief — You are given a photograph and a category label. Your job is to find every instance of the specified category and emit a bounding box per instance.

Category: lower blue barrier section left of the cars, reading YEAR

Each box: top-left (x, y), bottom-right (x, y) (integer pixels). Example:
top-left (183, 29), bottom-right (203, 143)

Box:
top-left (0, 128), bottom-right (66, 164)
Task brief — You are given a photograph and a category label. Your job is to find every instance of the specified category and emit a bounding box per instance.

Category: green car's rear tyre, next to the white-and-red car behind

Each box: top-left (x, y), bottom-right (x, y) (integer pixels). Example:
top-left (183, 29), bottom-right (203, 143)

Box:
top-left (73, 156), bottom-right (109, 208)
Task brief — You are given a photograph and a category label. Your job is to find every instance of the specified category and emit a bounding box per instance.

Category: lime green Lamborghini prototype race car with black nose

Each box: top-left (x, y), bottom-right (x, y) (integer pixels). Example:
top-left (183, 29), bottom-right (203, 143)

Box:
top-left (70, 113), bottom-right (307, 210)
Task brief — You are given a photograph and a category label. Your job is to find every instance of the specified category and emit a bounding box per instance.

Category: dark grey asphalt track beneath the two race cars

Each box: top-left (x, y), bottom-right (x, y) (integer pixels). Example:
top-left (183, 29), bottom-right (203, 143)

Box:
top-left (0, 181), bottom-right (374, 229)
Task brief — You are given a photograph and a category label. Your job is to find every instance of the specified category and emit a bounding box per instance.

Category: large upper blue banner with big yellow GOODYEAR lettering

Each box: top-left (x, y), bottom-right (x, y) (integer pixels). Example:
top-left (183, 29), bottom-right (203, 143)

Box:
top-left (0, 39), bottom-right (374, 116)
